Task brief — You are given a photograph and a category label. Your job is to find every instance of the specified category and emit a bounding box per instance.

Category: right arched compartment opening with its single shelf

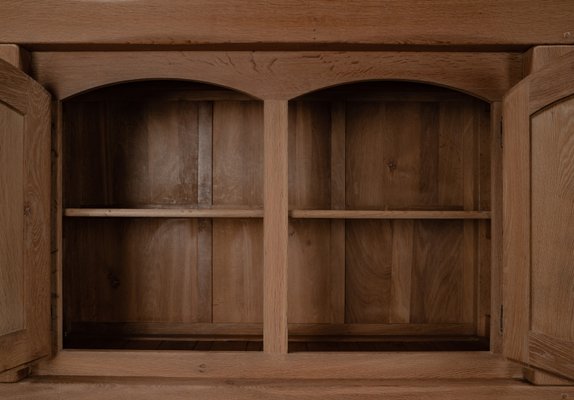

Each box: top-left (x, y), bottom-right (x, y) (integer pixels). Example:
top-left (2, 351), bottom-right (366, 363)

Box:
top-left (288, 81), bottom-right (491, 351)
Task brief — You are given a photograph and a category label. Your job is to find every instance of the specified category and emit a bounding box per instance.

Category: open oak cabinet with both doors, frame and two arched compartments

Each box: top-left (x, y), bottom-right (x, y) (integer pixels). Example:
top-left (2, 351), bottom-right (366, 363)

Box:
top-left (0, 46), bottom-right (574, 381)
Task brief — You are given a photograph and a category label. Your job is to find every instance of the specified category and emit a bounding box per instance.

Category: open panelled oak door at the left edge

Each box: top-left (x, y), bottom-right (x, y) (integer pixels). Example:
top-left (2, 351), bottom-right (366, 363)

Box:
top-left (0, 60), bottom-right (50, 381)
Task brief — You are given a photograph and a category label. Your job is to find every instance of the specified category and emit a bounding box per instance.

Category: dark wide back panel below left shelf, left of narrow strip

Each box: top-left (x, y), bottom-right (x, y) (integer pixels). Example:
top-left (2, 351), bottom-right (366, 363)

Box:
top-left (64, 219), bottom-right (201, 323)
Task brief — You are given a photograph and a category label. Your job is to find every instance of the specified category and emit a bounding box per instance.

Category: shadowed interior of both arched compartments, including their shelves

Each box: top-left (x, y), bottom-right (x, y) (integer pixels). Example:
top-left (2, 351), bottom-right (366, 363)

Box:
top-left (62, 81), bottom-right (491, 352)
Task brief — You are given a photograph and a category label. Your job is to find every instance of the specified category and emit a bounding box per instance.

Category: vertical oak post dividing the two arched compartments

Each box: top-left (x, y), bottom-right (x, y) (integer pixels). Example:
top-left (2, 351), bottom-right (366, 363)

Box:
top-left (263, 100), bottom-right (289, 354)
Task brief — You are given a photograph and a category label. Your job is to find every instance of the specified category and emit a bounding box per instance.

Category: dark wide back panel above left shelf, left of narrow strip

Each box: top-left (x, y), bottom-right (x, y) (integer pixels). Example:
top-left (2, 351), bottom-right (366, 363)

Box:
top-left (64, 97), bottom-right (198, 207)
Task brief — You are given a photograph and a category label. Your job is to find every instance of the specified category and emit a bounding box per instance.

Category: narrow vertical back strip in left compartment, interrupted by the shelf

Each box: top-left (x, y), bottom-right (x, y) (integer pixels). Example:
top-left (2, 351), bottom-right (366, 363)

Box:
top-left (197, 102), bottom-right (213, 322)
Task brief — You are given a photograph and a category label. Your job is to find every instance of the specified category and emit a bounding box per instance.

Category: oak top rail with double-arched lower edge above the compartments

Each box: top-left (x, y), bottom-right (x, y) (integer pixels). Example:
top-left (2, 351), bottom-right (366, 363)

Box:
top-left (32, 51), bottom-right (522, 101)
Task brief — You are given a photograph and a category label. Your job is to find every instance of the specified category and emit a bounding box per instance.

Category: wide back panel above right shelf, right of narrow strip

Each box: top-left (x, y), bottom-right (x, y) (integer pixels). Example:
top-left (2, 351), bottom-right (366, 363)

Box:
top-left (346, 101), bottom-right (488, 210)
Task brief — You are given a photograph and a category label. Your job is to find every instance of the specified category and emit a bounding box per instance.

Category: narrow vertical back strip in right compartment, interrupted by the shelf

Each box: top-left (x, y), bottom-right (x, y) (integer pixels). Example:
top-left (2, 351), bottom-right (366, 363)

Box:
top-left (329, 102), bottom-right (347, 323)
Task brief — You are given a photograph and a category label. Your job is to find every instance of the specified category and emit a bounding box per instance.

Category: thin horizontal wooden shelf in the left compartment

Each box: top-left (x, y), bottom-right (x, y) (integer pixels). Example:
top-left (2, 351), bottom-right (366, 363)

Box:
top-left (64, 208), bottom-right (263, 218)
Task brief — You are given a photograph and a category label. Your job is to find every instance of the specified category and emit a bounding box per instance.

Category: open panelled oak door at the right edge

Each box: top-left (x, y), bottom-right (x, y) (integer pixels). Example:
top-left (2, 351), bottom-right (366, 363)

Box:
top-left (503, 53), bottom-right (574, 379)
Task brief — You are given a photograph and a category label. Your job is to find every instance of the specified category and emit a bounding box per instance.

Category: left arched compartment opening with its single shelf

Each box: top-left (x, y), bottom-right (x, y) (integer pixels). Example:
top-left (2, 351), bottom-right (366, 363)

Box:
top-left (62, 80), bottom-right (263, 350)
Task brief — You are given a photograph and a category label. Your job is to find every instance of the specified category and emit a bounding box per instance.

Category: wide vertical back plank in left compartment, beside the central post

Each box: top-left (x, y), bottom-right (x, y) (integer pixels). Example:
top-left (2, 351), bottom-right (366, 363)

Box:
top-left (212, 101), bottom-right (264, 322)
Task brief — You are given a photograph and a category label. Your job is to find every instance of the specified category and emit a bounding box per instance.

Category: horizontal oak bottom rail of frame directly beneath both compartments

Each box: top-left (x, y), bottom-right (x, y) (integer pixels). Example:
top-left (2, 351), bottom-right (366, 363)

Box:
top-left (36, 350), bottom-right (521, 381)
